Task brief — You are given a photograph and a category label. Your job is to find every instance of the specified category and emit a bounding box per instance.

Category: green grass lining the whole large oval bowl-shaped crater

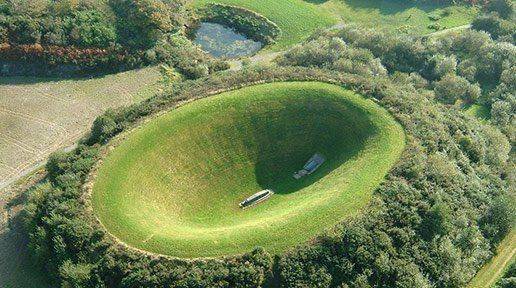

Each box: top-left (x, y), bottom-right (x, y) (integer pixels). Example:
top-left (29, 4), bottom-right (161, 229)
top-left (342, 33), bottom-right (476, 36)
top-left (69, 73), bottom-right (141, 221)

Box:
top-left (92, 82), bottom-right (404, 257)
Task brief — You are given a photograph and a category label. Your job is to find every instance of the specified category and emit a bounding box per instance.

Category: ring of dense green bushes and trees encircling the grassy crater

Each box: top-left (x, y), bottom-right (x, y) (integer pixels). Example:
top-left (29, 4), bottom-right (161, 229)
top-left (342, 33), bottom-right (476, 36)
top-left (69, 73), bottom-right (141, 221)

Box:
top-left (24, 58), bottom-right (515, 287)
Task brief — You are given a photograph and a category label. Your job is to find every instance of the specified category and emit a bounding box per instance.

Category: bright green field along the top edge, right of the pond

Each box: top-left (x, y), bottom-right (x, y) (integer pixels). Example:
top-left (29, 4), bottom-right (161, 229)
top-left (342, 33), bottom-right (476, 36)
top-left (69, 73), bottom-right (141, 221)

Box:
top-left (194, 0), bottom-right (478, 51)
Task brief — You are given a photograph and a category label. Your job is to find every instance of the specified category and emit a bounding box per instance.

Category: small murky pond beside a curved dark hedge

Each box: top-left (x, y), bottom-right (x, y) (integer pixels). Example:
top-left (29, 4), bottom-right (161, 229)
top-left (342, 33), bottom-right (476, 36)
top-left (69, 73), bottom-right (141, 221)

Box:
top-left (193, 22), bottom-right (263, 58)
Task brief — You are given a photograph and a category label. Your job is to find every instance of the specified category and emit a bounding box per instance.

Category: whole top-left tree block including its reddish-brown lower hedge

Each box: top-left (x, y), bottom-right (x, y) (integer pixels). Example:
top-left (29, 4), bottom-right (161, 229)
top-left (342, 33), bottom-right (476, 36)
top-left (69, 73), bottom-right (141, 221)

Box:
top-left (0, 0), bottom-right (227, 78)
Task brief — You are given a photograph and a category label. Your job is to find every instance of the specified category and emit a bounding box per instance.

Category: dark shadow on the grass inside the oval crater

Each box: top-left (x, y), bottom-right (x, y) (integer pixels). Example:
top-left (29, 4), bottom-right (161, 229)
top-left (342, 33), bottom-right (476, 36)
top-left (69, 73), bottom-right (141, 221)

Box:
top-left (249, 93), bottom-right (377, 194)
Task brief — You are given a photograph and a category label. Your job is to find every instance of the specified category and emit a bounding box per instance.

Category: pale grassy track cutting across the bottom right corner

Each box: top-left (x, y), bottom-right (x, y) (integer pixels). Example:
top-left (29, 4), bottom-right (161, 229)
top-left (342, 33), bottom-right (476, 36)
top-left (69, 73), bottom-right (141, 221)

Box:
top-left (468, 228), bottom-right (516, 288)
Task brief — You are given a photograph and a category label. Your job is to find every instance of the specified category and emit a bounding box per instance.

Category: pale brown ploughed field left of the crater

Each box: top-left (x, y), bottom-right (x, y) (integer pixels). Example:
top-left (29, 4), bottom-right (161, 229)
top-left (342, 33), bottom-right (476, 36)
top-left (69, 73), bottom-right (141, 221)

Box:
top-left (0, 68), bottom-right (159, 187)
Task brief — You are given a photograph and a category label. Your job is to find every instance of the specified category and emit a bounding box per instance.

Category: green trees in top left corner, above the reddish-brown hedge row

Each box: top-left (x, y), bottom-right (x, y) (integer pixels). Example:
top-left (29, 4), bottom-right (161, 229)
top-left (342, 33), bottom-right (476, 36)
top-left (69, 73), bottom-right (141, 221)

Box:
top-left (0, 0), bottom-right (184, 50)
